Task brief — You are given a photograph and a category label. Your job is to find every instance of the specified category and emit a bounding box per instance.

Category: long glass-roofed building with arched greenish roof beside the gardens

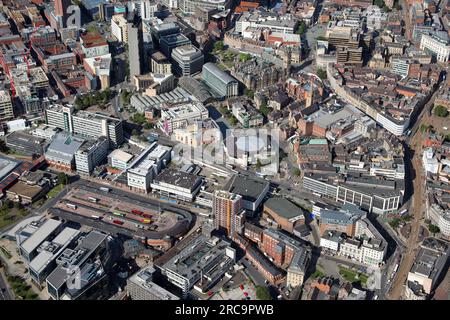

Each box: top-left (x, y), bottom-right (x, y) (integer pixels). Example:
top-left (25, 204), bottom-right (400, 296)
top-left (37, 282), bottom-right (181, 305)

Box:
top-left (202, 62), bottom-right (239, 98)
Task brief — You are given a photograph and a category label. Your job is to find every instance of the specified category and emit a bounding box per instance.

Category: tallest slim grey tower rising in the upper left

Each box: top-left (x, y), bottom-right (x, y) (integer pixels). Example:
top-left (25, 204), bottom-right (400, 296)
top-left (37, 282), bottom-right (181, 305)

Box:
top-left (127, 23), bottom-right (144, 77)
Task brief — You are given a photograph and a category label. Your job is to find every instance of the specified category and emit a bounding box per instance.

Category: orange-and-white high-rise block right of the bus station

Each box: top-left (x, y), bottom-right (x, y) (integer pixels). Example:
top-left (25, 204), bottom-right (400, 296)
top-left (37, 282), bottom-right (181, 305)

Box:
top-left (212, 190), bottom-right (244, 238)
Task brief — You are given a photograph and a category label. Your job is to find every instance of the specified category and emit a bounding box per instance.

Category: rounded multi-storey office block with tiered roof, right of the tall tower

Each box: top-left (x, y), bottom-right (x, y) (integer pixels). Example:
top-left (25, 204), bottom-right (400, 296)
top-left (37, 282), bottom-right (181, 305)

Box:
top-left (172, 45), bottom-right (203, 76)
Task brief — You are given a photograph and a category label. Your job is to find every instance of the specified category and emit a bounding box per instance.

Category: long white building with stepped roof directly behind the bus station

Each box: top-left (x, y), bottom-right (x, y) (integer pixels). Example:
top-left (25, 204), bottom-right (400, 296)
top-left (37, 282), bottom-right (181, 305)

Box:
top-left (127, 142), bottom-right (171, 193)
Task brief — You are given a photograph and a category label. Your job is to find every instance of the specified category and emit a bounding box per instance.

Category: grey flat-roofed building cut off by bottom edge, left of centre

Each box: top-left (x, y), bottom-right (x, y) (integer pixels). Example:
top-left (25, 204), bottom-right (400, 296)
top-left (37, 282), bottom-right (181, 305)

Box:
top-left (127, 267), bottom-right (180, 300)
